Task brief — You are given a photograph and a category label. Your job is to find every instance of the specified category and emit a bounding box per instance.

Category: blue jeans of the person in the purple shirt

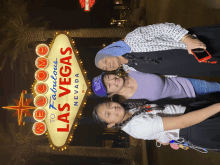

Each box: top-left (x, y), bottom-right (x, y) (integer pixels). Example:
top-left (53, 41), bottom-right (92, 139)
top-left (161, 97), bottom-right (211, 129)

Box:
top-left (187, 78), bottom-right (220, 96)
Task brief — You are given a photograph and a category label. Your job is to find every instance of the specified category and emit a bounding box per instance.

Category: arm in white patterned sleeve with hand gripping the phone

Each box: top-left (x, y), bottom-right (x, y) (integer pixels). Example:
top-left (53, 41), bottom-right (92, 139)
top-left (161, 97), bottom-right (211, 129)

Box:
top-left (124, 23), bottom-right (206, 54)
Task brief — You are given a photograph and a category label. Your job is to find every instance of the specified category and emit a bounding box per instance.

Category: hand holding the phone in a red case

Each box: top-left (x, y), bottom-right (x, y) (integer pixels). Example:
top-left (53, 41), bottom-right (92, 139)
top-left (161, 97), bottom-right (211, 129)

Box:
top-left (183, 37), bottom-right (206, 54)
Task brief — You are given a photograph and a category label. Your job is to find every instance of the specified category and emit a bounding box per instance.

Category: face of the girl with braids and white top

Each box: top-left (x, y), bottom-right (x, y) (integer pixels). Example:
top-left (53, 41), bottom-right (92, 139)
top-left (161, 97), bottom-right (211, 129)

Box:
top-left (97, 102), bottom-right (125, 124)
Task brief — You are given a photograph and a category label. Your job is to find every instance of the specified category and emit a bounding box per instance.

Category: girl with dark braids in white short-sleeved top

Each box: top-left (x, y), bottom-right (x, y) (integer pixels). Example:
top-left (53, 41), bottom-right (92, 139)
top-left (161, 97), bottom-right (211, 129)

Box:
top-left (93, 102), bottom-right (220, 150)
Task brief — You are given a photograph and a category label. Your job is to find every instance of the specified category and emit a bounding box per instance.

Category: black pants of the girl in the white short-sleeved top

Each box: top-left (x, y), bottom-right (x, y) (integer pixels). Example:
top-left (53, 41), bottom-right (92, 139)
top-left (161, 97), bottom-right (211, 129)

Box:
top-left (180, 101), bottom-right (220, 152)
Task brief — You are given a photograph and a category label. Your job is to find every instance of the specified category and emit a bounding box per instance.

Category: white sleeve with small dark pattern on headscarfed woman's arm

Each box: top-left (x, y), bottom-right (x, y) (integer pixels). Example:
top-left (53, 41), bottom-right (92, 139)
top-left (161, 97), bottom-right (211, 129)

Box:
top-left (124, 23), bottom-right (188, 43)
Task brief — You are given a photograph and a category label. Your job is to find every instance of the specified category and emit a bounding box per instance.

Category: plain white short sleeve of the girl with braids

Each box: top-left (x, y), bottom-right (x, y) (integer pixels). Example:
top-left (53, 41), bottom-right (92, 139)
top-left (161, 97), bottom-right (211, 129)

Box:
top-left (123, 115), bottom-right (164, 140)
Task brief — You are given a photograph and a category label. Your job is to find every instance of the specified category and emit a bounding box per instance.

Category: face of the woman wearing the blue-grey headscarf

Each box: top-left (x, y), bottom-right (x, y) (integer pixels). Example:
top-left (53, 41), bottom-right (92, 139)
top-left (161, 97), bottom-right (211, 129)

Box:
top-left (98, 57), bottom-right (120, 71)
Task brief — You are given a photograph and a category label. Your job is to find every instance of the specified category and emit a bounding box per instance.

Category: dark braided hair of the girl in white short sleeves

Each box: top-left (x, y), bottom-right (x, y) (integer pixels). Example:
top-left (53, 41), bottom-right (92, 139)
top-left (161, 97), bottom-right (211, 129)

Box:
top-left (93, 102), bottom-right (164, 128)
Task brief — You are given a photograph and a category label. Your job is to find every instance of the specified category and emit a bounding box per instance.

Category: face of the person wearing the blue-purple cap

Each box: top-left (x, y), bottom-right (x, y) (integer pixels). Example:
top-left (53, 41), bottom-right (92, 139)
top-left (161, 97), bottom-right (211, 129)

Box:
top-left (103, 74), bottom-right (124, 94)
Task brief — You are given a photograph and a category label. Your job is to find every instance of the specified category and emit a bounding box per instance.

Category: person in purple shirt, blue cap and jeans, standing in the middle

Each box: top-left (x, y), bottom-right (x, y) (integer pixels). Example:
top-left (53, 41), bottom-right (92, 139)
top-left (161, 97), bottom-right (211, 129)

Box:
top-left (92, 71), bottom-right (220, 101)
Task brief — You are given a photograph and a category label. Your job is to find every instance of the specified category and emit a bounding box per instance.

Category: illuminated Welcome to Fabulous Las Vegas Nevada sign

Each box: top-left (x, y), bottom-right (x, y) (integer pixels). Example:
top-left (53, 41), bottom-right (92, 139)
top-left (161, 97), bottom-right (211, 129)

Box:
top-left (33, 32), bottom-right (91, 150)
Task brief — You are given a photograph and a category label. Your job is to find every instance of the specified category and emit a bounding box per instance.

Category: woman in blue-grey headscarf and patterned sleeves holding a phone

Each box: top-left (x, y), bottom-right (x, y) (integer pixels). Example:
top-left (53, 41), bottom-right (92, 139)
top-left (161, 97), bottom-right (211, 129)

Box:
top-left (95, 23), bottom-right (220, 76)
